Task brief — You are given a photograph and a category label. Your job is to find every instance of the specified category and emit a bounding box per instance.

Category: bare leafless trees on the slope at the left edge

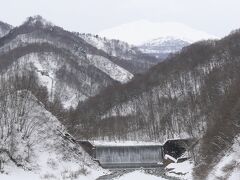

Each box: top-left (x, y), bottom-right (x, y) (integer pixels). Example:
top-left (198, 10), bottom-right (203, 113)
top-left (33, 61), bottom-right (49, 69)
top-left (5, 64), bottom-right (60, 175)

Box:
top-left (0, 72), bottom-right (50, 168)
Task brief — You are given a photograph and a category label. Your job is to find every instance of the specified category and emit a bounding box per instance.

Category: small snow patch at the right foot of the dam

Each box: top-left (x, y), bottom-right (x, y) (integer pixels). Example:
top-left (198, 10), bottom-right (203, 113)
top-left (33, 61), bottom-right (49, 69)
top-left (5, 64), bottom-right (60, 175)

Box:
top-left (165, 160), bottom-right (194, 180)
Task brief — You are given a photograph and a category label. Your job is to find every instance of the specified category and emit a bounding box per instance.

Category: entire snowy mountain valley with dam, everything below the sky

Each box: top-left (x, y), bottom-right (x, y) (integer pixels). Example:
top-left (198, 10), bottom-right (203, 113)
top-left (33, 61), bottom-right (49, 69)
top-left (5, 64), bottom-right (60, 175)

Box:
top-left (0, 5), bottom-right (240, 180)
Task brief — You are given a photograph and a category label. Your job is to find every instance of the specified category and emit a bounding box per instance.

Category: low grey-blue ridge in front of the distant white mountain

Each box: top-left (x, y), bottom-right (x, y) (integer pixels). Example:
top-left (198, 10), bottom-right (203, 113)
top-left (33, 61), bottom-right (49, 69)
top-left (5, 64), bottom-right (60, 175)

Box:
top-left (138, 37), bottom-right (190, 59)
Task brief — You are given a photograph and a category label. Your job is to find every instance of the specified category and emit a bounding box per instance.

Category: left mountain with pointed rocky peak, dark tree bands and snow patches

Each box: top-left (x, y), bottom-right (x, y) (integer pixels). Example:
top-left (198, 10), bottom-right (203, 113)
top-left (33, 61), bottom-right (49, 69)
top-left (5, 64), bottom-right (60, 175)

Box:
top-left (0, 16), bottom-right (133, 107)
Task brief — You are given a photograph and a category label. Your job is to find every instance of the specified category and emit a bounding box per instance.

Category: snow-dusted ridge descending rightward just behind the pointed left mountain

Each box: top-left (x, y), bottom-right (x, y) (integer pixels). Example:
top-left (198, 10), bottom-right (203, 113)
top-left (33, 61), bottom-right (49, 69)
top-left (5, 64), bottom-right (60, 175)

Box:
top-left (78, 34), bottom-right (162, 74)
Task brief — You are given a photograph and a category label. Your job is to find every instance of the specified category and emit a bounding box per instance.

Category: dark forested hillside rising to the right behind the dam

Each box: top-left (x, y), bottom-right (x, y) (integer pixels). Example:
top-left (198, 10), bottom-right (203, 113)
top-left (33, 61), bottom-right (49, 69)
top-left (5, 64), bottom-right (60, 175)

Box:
top-left (70, 30), bottom-right (240, 177)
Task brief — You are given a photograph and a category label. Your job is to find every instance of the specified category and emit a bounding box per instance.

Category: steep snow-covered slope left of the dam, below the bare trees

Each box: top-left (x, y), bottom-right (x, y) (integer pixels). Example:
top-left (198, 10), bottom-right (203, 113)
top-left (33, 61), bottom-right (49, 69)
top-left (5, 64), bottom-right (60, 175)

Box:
top-left (0, 92), bottom-right (108, 180)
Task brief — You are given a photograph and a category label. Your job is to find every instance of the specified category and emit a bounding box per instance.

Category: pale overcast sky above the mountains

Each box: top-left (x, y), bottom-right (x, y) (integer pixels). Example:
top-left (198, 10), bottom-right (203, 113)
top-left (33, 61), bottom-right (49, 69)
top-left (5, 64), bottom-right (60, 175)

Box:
top-left (0, 0), bottom-right (240, 36)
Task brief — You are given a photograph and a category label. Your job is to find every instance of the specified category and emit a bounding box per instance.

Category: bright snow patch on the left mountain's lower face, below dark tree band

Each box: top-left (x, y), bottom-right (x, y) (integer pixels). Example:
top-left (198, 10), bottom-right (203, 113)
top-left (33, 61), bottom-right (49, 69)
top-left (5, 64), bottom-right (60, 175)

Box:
top-left (5, 52), bottom-right (87, 109)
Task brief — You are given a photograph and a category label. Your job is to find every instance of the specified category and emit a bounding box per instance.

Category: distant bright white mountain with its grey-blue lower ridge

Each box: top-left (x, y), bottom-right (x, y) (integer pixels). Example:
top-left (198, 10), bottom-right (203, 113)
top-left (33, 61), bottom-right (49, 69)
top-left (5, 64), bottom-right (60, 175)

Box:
top-left (99, 20), bottom-right (216, 59)
